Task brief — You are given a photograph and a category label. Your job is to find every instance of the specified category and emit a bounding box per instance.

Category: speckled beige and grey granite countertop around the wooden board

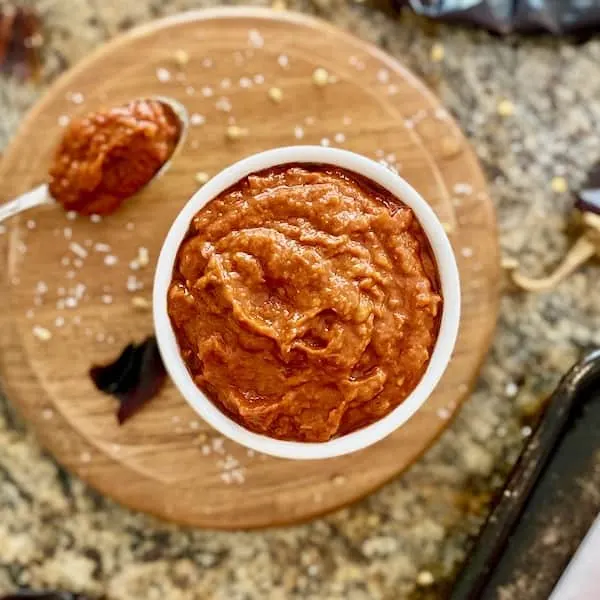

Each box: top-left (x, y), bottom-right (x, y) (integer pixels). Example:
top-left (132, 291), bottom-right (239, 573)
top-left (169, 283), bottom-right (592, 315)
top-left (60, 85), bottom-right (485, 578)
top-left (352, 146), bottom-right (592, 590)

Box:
top-left (0, 0), bottom-right (600, 600)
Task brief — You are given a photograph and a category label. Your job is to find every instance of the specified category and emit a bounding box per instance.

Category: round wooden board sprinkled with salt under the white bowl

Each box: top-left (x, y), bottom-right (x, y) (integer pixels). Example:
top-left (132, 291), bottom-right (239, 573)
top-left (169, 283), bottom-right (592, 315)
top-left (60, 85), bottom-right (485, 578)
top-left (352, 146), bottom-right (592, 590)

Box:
top-left (0, 9), bottom-right (499, 529)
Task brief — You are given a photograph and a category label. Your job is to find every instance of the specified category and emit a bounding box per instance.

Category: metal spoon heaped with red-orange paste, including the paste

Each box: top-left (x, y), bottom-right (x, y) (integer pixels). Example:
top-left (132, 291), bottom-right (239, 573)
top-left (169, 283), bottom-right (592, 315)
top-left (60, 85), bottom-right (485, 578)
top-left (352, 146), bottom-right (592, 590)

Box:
top-left (0, 96), bottom-right (189, 222)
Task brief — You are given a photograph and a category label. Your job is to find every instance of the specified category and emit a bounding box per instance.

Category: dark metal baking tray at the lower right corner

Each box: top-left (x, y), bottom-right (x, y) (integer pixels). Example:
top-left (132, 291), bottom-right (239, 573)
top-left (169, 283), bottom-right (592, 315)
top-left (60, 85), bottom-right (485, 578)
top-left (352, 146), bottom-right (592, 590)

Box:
top-left (449, 350), bottom-right (600, 600)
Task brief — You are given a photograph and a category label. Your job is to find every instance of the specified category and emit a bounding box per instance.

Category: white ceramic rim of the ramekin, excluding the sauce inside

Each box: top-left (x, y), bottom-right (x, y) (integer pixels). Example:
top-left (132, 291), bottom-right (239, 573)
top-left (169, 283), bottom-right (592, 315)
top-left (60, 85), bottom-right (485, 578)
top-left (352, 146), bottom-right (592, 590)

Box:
top-left (153, 146), bottom-right (460, 459)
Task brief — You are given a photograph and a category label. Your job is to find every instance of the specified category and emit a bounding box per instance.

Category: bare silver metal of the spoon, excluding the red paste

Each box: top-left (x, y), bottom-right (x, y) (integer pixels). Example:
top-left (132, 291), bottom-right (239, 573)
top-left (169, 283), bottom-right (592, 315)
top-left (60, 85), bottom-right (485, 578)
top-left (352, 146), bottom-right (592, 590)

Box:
top-left (0, 96), bottom-right (189, 223)
